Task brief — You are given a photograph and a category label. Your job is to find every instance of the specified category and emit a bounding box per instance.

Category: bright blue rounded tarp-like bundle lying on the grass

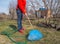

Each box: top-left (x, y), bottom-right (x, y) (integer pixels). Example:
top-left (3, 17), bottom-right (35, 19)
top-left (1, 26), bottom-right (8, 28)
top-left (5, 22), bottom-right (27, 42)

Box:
top-left (28, 29), bottom-right (43, 41)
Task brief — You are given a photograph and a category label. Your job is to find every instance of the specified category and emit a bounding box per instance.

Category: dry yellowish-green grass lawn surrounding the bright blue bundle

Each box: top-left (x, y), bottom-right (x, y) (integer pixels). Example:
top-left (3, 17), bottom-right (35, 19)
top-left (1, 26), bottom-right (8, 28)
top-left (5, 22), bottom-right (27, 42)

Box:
top-left (0, 20), bottom-right (60, 44)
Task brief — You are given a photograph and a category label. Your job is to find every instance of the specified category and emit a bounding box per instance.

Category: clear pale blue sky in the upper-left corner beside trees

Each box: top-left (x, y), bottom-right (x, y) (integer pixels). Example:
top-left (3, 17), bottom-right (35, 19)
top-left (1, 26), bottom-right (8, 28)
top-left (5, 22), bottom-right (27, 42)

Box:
top-left (0, 0), bottom-right (11, 13)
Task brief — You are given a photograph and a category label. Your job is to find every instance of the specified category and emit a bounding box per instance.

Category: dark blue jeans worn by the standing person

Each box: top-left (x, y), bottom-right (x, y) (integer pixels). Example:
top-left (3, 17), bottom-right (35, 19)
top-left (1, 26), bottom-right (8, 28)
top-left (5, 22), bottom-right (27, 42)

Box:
top-left (16, 8), bottom-right (23, 30)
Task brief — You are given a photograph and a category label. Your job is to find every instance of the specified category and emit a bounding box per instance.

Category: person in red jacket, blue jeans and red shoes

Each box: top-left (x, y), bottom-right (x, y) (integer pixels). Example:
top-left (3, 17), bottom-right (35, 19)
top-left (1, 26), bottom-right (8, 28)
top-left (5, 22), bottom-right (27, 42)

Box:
top-left (16, 0), bottom-right (26, 33)
